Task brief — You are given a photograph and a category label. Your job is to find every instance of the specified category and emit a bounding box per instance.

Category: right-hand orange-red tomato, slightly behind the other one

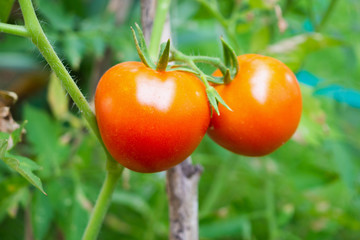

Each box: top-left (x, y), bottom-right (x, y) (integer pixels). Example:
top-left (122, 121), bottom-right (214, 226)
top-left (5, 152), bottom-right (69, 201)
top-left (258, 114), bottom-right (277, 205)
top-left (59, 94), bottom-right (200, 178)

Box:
top-left (208, 54), bottom-right (302, 156)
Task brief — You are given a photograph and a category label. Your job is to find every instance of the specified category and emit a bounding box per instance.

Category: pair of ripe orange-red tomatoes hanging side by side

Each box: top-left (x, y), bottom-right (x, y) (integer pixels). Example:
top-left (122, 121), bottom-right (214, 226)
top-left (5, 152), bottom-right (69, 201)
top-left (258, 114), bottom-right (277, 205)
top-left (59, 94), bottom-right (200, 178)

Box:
top-left (95, 54), bottom-right (302, 172)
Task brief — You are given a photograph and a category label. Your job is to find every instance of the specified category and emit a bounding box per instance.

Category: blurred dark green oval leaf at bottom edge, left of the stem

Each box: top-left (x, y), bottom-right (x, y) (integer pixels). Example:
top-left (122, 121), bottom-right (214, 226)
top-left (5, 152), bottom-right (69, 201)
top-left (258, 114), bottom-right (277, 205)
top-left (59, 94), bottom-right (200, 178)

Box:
top-left (31, 189), bottom-right (54, 240)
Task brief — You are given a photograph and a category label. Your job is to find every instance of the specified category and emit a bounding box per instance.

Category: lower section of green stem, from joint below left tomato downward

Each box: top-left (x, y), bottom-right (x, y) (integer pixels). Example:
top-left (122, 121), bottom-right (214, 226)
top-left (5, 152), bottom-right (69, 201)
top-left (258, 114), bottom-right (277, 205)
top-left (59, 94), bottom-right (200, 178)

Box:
top-left (82, 163), bottom-right (124, 240)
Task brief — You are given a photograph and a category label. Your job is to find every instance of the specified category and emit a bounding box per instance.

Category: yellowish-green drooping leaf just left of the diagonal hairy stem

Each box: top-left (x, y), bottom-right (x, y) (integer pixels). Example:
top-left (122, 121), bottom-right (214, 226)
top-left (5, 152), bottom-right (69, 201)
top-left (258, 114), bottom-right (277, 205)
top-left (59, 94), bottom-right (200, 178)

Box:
top-left (47, 73), bottom-right (69, 119)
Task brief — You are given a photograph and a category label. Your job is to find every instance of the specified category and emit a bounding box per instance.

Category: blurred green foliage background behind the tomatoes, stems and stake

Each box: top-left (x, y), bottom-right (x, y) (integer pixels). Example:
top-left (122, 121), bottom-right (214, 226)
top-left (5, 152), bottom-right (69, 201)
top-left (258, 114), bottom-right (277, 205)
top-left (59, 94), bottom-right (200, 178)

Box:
top-left (0, 0), bottom-right (360, 240)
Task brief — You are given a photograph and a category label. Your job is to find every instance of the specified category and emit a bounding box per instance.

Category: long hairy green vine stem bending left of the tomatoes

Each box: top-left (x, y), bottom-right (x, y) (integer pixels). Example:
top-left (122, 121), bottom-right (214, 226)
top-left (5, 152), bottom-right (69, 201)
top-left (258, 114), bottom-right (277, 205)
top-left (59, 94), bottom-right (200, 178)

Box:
top-left (16, 0), bottom-right (124, 240)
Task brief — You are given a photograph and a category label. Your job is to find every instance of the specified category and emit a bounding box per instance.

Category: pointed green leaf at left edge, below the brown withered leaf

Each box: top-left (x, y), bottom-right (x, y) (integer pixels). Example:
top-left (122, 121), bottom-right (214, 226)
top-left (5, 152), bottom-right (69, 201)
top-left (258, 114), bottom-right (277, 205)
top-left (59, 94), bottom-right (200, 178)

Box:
top-left (2, 153), bottom-right (46, 195)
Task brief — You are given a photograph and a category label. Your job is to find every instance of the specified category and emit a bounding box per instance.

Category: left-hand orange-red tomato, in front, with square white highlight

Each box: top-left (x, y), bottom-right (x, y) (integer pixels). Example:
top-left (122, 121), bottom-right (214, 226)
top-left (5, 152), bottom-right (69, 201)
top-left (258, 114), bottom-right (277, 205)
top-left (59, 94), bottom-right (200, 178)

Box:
top-left (95, 62), bottom-right (210, 173)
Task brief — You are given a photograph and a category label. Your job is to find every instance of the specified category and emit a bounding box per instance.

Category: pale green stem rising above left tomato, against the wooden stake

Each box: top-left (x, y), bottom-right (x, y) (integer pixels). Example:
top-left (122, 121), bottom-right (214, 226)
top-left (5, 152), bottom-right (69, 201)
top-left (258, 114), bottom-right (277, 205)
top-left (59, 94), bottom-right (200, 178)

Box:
top-left (149, 0), bottom-right (171, 59)
